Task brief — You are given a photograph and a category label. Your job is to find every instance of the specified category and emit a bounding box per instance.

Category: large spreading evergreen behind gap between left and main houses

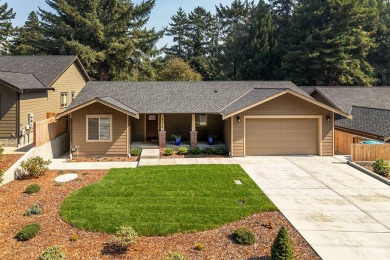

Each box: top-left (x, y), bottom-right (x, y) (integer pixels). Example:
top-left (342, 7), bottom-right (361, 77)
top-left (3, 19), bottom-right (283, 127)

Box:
top-left (39, 0), bottom-right (163, 80)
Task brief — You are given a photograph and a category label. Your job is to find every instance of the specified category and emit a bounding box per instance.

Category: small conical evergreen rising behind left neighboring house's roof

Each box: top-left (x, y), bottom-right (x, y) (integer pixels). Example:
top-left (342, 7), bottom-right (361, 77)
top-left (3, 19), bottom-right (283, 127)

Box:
top-left (10, 11), bottom-right (43, 55)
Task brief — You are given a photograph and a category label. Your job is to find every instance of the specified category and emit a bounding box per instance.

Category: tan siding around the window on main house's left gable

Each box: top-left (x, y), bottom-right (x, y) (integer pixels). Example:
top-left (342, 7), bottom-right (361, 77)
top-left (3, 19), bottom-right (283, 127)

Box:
top-left (72, 103), bottom-right (127, 155)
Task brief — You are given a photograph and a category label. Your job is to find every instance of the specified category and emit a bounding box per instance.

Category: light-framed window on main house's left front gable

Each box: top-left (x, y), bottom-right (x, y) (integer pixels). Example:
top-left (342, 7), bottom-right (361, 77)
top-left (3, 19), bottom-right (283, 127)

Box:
top-left (86, 115), bottom-right (112, 142)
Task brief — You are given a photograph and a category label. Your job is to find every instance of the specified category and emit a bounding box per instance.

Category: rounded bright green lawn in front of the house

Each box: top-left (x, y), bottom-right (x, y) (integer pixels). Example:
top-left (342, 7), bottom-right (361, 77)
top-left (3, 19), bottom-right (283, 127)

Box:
top-left (60, 165), bottom-right (276, 235)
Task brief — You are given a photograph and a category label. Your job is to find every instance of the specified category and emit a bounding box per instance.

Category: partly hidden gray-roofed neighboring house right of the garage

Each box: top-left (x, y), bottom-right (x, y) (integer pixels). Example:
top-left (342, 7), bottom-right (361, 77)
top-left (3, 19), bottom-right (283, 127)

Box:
top-left (303, 87), bottom-right (390, 154)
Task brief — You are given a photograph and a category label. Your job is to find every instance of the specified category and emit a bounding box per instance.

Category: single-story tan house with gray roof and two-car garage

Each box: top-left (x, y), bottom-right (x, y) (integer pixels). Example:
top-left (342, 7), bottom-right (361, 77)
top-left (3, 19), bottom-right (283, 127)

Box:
top-left (57, 81), bottom-right (350, 156)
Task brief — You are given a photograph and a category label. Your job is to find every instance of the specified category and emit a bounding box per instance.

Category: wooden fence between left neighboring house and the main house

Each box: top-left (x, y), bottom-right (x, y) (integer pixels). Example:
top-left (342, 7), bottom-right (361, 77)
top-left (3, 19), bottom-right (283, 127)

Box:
top-left (34, 117), bottom-right (68, 146)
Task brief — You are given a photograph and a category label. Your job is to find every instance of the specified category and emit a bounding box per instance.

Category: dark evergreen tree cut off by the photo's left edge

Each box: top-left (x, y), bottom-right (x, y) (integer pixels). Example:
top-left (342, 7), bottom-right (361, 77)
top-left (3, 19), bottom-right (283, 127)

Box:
top-left (0, 0), bottom-right (15, 55)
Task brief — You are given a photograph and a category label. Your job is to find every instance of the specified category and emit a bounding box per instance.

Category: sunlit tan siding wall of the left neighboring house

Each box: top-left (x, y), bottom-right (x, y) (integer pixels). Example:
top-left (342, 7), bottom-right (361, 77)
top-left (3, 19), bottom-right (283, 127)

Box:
top-left (20, 64), bottom-right (86, 125)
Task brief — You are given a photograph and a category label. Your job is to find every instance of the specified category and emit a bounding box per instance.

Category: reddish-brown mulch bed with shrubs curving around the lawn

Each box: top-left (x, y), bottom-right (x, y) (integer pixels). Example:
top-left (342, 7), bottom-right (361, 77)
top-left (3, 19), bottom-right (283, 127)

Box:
top-left (0, 171), bottom-right (320, 260)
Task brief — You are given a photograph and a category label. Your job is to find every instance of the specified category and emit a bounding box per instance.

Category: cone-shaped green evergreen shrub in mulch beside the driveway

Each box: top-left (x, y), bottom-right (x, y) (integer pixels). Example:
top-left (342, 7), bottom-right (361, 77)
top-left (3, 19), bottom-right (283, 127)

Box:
top-left (271, 227), bottom-right (294, 260)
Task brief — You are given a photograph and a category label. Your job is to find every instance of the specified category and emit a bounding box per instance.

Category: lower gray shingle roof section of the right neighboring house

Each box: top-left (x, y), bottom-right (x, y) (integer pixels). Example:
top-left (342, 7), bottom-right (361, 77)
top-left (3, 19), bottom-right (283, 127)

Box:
top-left (335, 106), bottom-right (390, 139)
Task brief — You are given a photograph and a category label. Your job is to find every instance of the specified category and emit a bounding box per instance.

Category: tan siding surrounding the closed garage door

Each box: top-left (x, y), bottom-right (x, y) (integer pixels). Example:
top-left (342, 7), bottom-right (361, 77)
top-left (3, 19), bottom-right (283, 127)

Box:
top-left (232, 94), bottom-right (334, 156)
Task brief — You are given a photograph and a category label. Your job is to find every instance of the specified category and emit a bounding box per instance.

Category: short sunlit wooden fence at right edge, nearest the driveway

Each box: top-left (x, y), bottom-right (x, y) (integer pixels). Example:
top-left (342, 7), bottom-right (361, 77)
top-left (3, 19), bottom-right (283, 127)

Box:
top-left (351, 144), bottom-right (390, 162)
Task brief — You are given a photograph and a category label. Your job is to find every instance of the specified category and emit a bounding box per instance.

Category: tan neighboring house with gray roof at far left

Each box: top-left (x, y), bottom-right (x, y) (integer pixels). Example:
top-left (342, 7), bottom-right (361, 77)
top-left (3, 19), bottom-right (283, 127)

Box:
top-left (0, 56), bottom-right (90, 146)
